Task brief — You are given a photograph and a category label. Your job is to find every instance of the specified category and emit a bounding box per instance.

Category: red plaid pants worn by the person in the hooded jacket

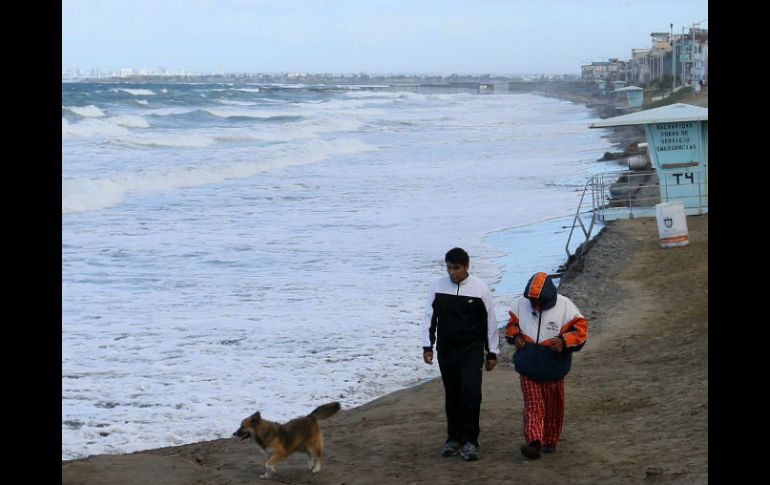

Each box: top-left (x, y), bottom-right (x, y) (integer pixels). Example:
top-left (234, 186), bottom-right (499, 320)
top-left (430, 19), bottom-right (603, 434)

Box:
top-left (519, 374), bottom-right (564, 445)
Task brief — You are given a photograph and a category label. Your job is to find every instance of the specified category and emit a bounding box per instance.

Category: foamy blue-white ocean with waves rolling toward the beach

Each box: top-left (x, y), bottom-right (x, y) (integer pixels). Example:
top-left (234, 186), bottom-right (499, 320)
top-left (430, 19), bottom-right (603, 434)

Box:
top-left (62, 83), bottom-right (617, 459)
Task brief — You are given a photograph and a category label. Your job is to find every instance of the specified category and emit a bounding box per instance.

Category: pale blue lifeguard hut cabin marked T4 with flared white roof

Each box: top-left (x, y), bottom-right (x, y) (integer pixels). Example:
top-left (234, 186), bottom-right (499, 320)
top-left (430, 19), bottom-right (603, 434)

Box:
top-left (589, 103), bottom-right (708, 215)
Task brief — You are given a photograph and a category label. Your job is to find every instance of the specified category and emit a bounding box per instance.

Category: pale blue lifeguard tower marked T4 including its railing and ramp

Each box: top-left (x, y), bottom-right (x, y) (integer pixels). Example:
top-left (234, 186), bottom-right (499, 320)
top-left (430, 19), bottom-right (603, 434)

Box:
top-left (567, 103), bottom-right (708, 260)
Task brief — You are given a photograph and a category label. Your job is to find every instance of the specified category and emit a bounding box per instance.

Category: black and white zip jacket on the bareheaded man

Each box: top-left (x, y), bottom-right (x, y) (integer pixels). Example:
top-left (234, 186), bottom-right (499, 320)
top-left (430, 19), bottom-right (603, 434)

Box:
top-left (422, 275), bottom-right (500, 359)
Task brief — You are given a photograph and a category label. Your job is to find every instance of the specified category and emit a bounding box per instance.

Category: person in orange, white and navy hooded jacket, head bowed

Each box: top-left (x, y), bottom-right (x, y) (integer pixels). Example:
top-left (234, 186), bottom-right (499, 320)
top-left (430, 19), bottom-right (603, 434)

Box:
top-left (505, 272), bottom-right (588, 459)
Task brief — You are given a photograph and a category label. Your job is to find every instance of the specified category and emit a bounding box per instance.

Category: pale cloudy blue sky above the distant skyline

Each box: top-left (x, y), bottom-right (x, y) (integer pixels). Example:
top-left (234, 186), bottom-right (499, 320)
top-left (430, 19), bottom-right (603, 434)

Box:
top-left (62, 0), bottom-right (708, 75)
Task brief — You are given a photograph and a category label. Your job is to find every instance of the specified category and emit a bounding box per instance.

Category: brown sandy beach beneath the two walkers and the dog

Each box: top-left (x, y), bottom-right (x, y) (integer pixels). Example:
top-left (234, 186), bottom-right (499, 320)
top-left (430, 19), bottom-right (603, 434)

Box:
top-left (62, 88), bottom-right (708, 485)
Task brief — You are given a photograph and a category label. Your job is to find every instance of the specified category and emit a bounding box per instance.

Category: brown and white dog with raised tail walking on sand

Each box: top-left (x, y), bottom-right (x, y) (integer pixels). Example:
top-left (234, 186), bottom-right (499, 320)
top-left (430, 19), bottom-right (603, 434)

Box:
top-left (233, 402), bottom-right (341, 478)
